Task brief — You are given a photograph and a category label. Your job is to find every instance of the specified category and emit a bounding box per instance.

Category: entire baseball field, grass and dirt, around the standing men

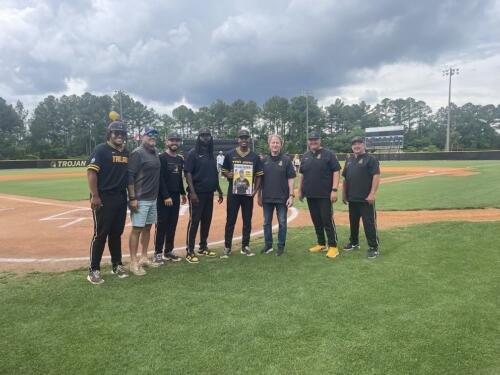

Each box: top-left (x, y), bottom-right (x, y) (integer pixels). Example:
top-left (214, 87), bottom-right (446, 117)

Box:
top-left (0, 161), bottom-right (500, 375)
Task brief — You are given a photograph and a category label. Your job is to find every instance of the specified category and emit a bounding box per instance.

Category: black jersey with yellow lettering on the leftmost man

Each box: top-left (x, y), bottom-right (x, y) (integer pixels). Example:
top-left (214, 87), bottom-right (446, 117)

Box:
top-left (87, 142), bottom-right (129, 193)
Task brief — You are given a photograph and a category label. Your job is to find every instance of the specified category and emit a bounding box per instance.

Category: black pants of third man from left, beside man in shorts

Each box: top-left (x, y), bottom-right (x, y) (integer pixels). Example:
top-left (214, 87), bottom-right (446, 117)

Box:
top-left (155, 193), bottom-right (181, 255)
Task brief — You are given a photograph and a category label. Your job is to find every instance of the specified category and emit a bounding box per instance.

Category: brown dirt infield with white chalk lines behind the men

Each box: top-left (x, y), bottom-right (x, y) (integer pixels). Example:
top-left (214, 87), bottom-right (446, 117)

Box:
top-left (0, 167), bottom-right (500, 271)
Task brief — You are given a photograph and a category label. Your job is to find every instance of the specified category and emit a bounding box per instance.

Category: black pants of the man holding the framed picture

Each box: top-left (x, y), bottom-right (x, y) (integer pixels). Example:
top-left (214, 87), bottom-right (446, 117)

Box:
top-left (224, 194), bottom-right (253, 249)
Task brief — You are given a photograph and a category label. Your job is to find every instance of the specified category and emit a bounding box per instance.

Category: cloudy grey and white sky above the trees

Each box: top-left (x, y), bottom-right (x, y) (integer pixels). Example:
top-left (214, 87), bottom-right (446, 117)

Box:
top-left (0, 0), bottom-right (500, 111)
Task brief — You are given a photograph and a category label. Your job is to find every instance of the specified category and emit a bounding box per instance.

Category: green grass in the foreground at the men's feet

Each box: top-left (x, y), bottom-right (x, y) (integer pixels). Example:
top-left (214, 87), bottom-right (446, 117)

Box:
top-left (0, 222), bottom-right (500, 375)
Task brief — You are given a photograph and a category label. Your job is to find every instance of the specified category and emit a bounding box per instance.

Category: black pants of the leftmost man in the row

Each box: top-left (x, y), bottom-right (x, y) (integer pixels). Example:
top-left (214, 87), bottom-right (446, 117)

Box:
top-left (89, 191), bottom-right (127, 271)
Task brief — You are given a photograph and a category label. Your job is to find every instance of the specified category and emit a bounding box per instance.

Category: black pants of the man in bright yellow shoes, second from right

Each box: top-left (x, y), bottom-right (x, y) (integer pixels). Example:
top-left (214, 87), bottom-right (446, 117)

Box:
top-left (307, 198), bottom-right (337, 247)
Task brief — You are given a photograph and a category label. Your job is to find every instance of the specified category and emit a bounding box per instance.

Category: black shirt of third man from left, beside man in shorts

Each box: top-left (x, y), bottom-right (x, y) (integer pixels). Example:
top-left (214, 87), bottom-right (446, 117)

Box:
top-left (159, 152), bottom-right (186, 200)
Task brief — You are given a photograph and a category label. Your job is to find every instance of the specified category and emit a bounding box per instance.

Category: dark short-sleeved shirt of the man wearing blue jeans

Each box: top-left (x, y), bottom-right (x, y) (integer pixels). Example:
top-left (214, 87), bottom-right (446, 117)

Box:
top-left (262, 154), bottom-right (295, 203)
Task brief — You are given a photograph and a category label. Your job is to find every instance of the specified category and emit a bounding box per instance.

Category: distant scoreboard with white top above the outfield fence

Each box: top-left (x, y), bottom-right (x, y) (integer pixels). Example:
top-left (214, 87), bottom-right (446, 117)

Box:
top-left (365, 126), bottom-right (404, 152)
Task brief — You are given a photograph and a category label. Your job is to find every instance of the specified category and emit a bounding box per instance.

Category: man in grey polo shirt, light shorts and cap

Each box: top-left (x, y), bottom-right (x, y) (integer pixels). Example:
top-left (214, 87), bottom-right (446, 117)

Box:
top-left (128, 128), bottom-right (160, 276)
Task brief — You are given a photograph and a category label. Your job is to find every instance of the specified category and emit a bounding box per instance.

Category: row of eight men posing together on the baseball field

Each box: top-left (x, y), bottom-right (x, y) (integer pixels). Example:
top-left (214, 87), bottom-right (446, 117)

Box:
top-left (87, 121), bottom-right (380, 284)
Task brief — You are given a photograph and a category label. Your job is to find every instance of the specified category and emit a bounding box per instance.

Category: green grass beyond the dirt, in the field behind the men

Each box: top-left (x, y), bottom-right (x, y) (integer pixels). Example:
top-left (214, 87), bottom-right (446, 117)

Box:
top-left (0, 160), bottom-right (500, 211)
